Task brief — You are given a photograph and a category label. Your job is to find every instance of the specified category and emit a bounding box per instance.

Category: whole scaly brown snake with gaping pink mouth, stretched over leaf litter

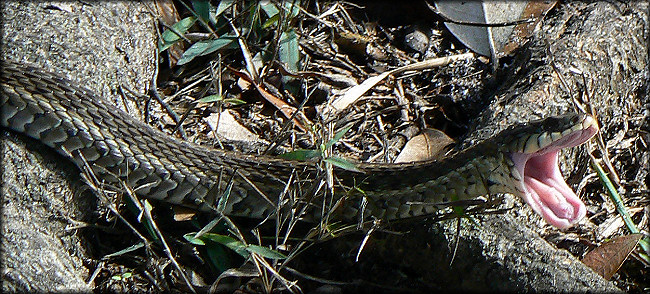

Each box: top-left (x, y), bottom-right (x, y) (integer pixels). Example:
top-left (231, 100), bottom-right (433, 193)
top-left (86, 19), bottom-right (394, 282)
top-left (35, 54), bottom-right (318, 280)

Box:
top-left (0, 61), bottom-right (599, 229)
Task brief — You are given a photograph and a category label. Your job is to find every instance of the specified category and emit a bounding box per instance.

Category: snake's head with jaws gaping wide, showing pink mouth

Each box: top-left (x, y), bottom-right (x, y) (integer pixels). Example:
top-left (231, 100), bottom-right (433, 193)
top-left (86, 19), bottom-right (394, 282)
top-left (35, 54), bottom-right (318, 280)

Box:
top-left (506, 113), bottom-right (598, 229)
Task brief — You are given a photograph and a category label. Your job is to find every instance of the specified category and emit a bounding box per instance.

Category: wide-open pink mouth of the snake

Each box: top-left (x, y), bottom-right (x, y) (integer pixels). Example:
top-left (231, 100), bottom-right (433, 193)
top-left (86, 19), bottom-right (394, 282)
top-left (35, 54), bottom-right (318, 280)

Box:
top-left (511, 117), bottom-right (598, 229)
